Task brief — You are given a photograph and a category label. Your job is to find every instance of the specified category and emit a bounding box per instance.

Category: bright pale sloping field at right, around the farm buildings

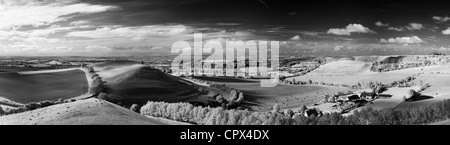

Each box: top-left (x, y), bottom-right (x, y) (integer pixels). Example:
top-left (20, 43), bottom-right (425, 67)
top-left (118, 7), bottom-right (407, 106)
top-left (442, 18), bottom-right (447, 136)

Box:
top-left (288, 58), bottom-right (450, 113)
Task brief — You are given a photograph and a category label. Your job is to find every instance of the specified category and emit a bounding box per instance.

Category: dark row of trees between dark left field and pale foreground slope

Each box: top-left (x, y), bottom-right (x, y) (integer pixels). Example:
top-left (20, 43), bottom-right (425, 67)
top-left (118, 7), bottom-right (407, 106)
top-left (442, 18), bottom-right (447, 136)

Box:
top-left (0, 99), bottom-right (65, 115)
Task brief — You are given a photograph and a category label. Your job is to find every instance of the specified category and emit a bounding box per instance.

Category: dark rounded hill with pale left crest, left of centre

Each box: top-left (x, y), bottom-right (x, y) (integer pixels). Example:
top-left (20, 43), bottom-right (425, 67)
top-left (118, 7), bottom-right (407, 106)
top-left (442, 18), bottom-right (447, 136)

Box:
top-left (94, 63), bottom-right (206, 105)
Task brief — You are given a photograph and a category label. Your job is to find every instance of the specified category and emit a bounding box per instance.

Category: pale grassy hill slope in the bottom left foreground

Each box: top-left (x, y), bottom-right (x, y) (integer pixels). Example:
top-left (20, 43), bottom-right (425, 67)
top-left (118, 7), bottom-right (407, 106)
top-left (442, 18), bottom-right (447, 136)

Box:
top-left (0, 98), bottom-right (177, 125)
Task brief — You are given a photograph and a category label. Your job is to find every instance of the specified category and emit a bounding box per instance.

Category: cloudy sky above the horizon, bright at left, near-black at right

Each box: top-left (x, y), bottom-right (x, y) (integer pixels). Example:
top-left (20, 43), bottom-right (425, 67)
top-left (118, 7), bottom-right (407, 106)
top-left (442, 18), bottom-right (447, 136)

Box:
top-left (0, 0), bottom-right (450, 56)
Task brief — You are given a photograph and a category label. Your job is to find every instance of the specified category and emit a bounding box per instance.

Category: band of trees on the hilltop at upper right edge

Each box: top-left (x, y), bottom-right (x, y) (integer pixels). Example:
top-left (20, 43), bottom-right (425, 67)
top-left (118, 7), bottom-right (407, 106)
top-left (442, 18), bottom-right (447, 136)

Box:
top-left (370, 55), bottom-right (450, 72)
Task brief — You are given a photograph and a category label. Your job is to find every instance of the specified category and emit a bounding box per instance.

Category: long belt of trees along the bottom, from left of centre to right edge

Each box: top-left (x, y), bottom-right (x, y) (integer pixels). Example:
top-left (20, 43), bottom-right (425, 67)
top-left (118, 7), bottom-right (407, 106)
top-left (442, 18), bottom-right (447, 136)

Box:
top-left (141, 100), bottom-right (450, 125)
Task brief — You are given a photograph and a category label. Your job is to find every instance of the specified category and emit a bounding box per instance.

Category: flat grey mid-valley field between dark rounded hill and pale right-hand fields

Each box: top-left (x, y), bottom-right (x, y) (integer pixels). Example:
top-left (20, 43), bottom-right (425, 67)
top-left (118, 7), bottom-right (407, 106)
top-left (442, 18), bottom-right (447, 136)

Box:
top-left (194, 76), bottom-right (346, 111)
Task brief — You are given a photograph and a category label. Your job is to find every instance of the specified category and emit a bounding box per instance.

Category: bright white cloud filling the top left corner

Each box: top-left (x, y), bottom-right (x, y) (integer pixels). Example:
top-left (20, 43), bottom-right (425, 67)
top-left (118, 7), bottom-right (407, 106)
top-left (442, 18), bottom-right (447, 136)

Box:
top-left (0, 0), bottom-right (118, 30)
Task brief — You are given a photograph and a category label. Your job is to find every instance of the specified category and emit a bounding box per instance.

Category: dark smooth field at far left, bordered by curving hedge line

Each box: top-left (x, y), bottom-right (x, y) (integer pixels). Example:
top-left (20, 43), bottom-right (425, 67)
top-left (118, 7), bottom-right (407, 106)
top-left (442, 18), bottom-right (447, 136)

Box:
top-left (0, 69), bottom-right (88, 103)
